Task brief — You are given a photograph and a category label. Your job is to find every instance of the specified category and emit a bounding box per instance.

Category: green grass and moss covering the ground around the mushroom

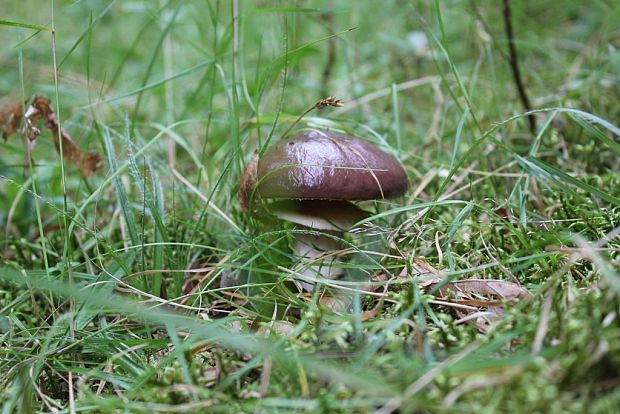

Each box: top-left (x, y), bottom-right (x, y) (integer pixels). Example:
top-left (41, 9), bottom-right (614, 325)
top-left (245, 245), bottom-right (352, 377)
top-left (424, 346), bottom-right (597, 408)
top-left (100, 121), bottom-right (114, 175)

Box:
top-left (0, 0), bottom-right (620, 413)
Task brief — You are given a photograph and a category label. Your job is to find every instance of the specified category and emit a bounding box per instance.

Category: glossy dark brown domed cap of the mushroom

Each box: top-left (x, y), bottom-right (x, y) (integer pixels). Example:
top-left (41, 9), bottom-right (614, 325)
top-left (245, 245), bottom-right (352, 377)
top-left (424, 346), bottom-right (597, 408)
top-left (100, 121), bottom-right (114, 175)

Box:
top-left (257, 130), bottom-right (408, 200)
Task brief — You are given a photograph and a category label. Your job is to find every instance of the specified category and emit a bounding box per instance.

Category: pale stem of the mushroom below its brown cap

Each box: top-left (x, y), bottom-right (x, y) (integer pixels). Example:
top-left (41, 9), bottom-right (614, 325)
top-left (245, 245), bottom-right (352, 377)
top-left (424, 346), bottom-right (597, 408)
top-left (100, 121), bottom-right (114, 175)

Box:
top-left (292, 227), bottom-right (344, 291)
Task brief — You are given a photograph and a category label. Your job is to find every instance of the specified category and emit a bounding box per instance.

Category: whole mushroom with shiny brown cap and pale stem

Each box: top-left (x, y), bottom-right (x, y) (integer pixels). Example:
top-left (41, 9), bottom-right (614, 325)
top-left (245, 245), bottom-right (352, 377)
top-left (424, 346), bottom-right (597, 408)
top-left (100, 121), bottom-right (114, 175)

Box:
top-left (238, 130), bottom-right (408, 290)
